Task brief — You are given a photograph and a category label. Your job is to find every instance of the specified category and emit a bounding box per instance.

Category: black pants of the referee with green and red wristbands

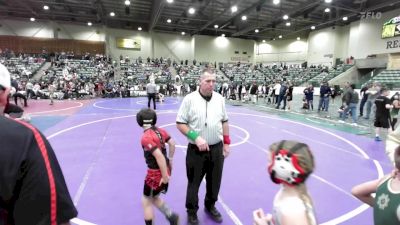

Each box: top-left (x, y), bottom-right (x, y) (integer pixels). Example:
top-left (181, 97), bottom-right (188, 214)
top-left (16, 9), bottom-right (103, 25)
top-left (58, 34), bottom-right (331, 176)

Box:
top-left (186, 142), bottom-right (224, 213)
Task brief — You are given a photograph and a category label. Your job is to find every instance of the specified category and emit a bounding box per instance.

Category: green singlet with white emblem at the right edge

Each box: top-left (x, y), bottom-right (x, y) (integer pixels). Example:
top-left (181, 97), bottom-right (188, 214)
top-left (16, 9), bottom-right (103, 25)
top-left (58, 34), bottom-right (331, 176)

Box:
top-left (374, 178), bottom-right (400, 225)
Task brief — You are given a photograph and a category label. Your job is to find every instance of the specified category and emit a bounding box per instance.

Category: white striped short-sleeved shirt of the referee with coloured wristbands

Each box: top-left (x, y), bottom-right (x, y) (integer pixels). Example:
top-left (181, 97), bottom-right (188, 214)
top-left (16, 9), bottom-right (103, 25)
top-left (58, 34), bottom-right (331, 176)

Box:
top-left (176, 91), bottom-right (228, 145)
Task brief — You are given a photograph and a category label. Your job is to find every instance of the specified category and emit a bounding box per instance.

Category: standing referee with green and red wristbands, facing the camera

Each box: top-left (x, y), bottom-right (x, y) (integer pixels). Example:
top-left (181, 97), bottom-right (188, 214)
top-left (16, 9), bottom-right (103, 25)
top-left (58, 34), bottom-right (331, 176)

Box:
top-left (176, 69), bottom-right (230, 225)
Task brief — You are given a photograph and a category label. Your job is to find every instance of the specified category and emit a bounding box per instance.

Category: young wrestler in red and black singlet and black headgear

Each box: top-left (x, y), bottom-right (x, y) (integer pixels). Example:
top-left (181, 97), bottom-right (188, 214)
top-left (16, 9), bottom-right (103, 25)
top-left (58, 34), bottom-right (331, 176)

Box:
top-left (136, 109), bottom-right (179, 225)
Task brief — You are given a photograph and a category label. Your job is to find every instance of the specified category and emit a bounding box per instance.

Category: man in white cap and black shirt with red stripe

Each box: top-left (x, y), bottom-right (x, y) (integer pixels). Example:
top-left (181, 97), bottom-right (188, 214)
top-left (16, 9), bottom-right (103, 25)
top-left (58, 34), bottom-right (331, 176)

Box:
top-left (0, 64), bottom-right (78, 225)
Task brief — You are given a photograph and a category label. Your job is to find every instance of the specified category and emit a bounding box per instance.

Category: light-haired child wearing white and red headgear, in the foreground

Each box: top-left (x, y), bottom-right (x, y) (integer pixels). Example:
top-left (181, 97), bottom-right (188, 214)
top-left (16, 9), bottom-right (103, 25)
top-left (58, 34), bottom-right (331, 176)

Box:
top-left (253, 140), bottom-right (317, 225)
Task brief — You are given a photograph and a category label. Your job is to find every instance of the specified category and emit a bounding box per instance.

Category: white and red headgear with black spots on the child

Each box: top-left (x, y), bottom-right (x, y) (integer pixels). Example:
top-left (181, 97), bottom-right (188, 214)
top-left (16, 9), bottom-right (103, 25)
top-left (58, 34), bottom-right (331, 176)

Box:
top-left (268, 141), bottom-right (309, 186)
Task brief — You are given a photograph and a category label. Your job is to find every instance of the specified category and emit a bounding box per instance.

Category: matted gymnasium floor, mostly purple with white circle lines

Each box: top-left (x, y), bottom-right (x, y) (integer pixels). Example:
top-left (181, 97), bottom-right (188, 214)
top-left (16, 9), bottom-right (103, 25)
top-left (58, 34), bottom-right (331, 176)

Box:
top-left (25, 98), bottom-right (391, 225)
